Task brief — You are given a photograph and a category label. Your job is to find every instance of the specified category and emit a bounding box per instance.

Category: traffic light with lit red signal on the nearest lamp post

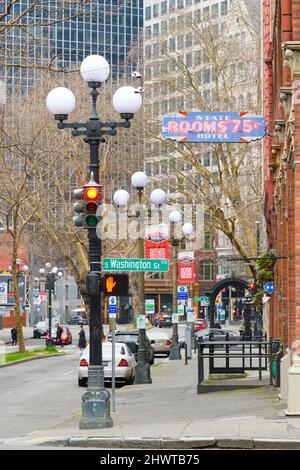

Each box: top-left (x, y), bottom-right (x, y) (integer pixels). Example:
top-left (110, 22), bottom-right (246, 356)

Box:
top-left (73, 173), bottom-right (101, 228)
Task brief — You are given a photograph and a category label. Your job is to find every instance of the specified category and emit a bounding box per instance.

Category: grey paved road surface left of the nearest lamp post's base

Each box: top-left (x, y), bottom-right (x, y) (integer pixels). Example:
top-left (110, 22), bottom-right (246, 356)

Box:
top-left (0, 349), bottom-right (82, 438)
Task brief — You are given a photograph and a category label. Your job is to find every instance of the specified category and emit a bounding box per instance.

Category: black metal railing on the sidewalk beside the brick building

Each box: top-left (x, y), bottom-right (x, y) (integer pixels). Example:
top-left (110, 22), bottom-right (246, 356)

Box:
top-left (197, 334), bottom-right (280, 393)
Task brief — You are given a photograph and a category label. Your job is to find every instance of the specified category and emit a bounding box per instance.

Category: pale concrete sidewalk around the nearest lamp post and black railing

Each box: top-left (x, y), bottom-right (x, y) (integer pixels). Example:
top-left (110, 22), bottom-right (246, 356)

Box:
top-left (3, 357), bottom-right (300, 449)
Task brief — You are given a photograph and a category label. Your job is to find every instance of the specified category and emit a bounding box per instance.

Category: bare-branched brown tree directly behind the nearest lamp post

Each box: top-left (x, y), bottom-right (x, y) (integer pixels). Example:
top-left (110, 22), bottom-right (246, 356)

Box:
top-left (3, 72), bottom-right (145, 320)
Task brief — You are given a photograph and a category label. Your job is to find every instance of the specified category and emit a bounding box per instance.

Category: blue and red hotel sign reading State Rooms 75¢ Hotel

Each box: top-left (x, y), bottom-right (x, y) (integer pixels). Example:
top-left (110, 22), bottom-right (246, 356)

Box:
top-left (162, 111), bottom-right (266, 143)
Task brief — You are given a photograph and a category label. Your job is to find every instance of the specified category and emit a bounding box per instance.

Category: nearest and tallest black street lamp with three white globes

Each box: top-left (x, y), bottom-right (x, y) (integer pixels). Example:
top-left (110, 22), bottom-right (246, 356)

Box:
top-left (47, 55), bottom-right (142, 429)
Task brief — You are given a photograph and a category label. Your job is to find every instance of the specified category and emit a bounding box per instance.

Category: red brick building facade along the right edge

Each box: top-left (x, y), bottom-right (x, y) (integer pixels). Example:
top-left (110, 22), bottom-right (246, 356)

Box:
top-left (264, 0), bottom-right (300, 346)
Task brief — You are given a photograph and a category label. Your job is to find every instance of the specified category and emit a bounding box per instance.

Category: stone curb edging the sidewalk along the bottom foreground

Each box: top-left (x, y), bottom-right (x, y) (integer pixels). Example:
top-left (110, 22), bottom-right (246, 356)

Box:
top-left (36, 436), bottom-right (300, 450)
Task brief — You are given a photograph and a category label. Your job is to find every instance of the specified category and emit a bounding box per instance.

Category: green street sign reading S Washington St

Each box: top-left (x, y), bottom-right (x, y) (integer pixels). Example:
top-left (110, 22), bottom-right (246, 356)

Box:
top-left (102, 258), bottom-right (169, 273)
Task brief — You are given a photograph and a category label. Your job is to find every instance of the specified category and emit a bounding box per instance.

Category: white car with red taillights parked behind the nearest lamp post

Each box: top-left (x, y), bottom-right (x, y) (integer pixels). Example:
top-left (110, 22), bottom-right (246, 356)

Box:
top-left (78, 343), bottom-right (136, 386)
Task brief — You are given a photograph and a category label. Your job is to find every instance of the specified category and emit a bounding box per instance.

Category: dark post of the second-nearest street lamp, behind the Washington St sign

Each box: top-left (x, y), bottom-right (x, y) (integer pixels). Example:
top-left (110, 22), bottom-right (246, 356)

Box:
top-left (134, 188), bottom-right (152, 384)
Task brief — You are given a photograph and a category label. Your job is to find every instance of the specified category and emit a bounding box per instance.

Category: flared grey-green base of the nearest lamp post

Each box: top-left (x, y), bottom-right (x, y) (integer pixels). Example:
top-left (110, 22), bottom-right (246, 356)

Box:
top-left (79, 366), bottom-right (113, 429)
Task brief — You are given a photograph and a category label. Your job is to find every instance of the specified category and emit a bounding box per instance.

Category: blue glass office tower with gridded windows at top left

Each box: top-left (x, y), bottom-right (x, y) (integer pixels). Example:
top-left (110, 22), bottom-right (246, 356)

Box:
top-left (0, 0), bottom-right (143, 101)
